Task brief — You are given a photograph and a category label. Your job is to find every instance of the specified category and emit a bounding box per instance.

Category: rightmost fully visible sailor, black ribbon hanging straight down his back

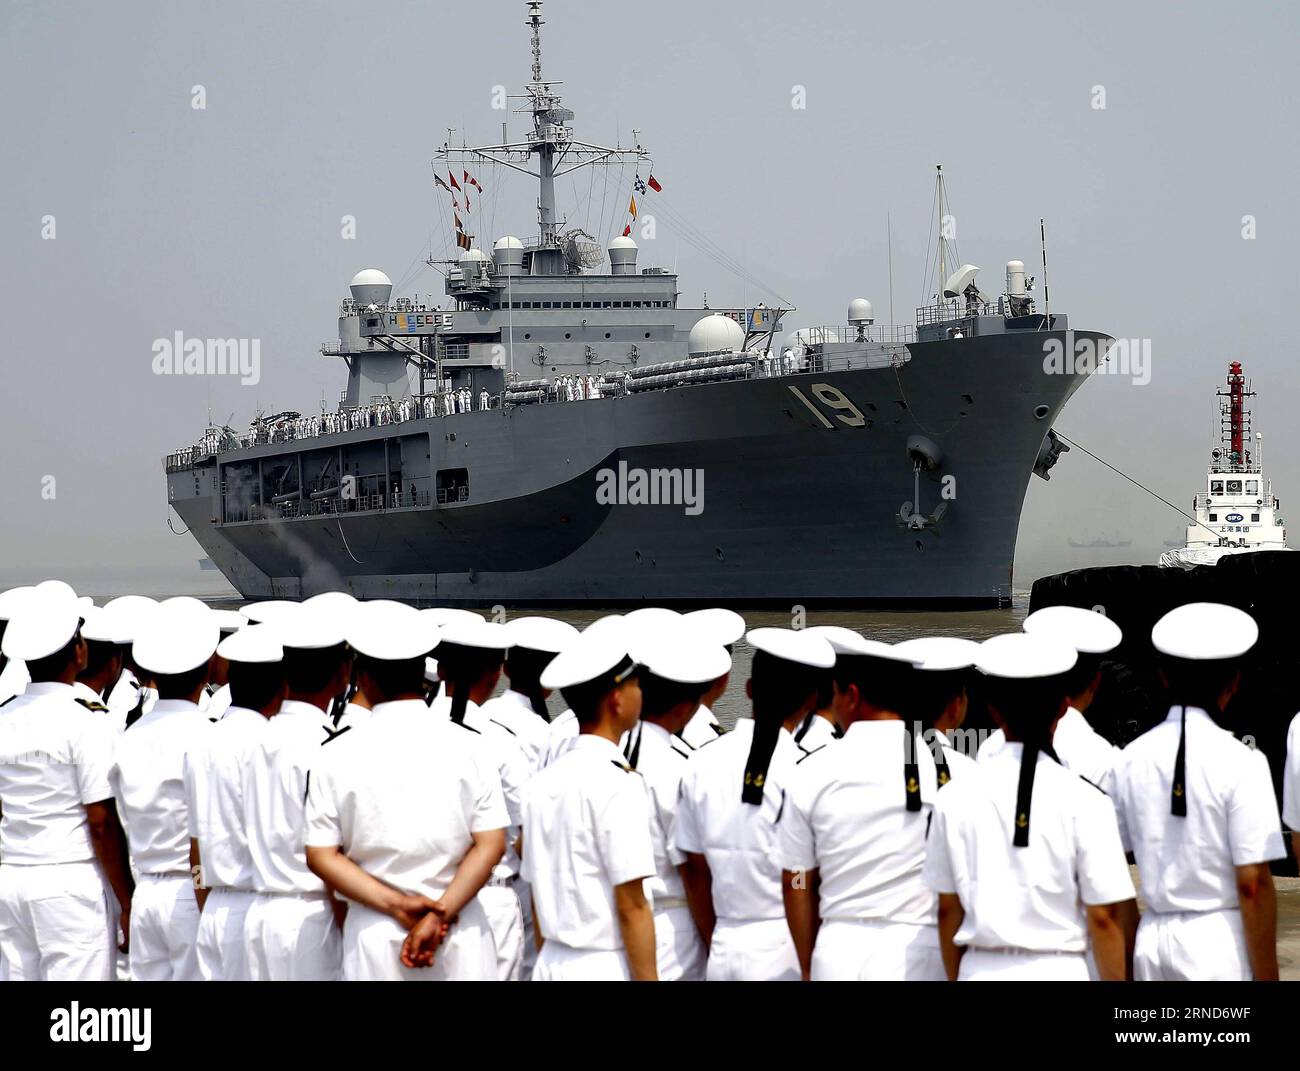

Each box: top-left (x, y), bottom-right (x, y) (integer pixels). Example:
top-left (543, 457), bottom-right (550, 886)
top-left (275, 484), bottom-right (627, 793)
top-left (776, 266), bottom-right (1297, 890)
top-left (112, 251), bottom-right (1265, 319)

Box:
top-left (1114, 603), bottom-right (1286, 981)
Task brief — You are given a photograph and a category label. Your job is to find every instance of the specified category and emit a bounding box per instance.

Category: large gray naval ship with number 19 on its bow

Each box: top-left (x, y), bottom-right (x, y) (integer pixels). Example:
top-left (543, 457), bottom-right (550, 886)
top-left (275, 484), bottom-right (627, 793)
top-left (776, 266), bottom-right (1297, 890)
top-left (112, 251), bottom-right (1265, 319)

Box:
top-left (165, 3), bottom-right (1112, 610)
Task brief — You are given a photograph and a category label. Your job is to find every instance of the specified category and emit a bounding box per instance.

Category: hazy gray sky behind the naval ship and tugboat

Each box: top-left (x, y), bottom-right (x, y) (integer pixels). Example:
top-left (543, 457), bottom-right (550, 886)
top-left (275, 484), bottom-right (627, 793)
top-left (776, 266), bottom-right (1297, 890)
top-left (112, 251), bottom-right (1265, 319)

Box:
top-left (0, 0), bottom-right (1300, 590)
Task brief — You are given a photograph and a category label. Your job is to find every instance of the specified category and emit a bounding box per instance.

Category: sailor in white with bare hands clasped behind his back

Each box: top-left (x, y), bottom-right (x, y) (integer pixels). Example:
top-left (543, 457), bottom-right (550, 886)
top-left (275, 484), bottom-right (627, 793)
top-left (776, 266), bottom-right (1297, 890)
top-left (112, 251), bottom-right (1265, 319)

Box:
top-left (306, 603), bottom-right (510, 981)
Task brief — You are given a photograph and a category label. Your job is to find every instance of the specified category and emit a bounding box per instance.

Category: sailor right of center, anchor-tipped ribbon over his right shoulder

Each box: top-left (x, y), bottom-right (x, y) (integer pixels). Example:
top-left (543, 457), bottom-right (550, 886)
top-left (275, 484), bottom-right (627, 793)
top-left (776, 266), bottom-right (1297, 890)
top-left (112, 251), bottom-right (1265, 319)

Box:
top-left (779, 629), bottom-right (945, 981)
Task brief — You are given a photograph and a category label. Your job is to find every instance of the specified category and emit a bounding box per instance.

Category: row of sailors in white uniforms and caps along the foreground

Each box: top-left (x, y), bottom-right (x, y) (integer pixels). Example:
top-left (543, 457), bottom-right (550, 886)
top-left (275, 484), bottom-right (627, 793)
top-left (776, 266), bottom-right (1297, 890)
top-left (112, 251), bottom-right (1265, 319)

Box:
top-left (0, 590), bottom-right (1300, 980)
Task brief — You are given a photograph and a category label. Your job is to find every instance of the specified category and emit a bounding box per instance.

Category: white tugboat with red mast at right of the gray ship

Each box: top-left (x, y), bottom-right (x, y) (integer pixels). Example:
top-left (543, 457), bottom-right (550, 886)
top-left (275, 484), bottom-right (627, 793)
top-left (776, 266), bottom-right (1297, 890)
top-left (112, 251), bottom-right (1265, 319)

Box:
top-left (1160, 361), bottom-right (1291, 569)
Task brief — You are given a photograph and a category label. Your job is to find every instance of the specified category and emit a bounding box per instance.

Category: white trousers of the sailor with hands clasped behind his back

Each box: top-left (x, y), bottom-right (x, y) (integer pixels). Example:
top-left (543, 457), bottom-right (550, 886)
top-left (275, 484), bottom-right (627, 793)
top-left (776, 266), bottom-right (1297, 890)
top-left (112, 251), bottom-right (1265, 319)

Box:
top-left (343, 899), bottom-right (497, 981)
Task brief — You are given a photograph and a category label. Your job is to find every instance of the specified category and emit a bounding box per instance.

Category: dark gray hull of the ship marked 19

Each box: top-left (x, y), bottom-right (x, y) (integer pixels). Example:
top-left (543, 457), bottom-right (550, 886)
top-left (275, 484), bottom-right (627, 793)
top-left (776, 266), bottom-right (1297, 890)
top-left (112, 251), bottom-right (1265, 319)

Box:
top-left (168, 331), bottom-right (1106, 610)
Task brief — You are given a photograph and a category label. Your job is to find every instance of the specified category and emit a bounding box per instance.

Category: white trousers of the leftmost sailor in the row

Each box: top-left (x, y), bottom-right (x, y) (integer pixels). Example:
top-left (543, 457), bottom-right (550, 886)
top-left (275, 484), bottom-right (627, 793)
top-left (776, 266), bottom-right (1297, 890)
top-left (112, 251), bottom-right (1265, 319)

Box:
top-left (0, 862), bottom-right (116, 981)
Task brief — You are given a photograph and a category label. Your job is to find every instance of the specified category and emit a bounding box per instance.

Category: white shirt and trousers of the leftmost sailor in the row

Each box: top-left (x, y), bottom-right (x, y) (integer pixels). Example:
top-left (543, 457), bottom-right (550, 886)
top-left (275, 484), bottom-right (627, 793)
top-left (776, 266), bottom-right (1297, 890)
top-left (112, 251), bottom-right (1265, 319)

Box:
top-left (0, 682), bottom-right (117, 981)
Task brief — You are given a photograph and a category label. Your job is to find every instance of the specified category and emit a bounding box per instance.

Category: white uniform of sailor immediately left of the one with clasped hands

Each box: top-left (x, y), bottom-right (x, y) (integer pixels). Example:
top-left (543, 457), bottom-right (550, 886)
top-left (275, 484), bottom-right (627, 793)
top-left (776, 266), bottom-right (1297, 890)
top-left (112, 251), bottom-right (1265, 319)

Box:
top-left (243, 699), bottom-right (343, 981)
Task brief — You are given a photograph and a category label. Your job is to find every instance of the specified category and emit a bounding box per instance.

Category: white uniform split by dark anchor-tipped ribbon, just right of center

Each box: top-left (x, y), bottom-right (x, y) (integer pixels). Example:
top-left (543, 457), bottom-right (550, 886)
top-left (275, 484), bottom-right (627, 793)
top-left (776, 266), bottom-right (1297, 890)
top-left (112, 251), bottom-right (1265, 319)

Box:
top-left (677, 717), bottom-right (800, 981)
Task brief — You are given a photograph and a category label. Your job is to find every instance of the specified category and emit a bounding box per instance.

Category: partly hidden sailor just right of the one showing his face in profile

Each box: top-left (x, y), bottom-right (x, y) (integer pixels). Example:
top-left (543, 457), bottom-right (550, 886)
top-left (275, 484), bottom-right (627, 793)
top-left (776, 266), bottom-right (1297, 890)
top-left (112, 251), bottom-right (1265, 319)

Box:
top-left (624, 630), bottom-right (731, 981)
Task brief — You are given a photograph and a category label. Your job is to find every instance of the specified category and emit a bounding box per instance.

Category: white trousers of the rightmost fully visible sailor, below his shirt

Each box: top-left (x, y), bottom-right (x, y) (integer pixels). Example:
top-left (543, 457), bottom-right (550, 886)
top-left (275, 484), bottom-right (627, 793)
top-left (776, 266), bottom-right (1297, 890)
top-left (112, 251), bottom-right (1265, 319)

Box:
top-left (1134, 907), bottom-right (1253, 981)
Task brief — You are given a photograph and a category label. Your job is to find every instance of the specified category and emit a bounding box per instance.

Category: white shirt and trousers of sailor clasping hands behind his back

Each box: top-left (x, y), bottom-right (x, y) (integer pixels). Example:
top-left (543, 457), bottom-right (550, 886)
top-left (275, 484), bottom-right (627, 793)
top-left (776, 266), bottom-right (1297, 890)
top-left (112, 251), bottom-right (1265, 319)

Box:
top-left (306, 699), bottom-right (510, 981)
